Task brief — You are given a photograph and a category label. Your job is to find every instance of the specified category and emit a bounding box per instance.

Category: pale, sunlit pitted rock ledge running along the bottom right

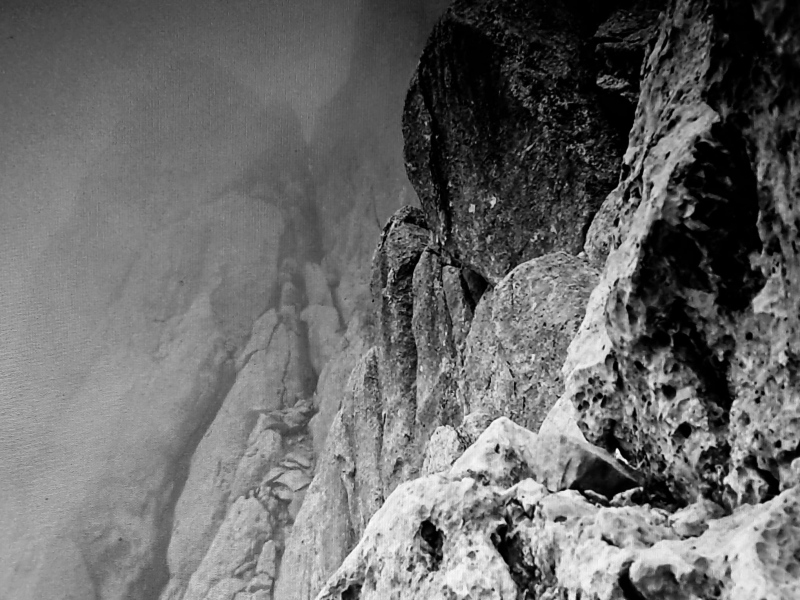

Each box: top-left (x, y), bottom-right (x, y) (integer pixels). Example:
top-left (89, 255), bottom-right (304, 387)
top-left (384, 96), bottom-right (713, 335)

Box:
top-left (317, 420), bottom-right (800, 600)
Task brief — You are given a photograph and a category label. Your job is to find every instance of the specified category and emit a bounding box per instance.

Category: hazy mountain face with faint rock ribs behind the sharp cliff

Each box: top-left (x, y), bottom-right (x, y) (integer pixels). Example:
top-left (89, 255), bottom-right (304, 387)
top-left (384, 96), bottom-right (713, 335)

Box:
top-left (0, 2), bottom-right (450, 600)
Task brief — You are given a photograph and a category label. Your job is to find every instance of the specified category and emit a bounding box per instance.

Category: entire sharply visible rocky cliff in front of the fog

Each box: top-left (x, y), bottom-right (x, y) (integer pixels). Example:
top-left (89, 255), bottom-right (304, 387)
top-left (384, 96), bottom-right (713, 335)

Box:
top-left (275, 0), bottom-right (800, 600)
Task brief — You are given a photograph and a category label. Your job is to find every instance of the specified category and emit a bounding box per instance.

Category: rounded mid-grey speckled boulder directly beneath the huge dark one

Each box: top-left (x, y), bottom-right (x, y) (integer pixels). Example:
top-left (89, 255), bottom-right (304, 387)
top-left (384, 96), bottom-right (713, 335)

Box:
top-left (459, 252), bottom-right (597, 429)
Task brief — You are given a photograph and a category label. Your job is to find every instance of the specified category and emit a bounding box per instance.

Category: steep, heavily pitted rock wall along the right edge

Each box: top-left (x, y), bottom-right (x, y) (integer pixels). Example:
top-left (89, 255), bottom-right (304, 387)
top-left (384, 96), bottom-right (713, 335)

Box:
top-left (565, 0), bottom-right (800, 507)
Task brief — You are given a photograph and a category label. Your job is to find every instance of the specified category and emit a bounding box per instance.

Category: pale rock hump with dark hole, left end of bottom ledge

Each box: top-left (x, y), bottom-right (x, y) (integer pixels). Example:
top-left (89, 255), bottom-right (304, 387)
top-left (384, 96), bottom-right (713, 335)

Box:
top-left (316, 475), bottom-right (518, 600)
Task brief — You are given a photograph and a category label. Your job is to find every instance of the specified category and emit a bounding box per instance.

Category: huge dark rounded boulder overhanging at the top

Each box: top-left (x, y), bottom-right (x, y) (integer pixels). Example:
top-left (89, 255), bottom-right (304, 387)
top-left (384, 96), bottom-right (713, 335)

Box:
top-left (403, 0), bottom-right (627, 284)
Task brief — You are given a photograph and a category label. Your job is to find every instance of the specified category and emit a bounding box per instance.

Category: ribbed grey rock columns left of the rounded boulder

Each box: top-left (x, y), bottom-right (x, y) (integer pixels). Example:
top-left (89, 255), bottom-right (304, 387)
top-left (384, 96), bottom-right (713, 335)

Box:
top-left (275, 207), bottom-right (482, 600)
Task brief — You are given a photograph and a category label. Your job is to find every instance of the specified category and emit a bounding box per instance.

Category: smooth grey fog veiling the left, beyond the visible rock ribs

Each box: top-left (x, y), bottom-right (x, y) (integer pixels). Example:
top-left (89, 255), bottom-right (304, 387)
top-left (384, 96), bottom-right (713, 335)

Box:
top-left (0, 0), bottom-right (444, 600)
